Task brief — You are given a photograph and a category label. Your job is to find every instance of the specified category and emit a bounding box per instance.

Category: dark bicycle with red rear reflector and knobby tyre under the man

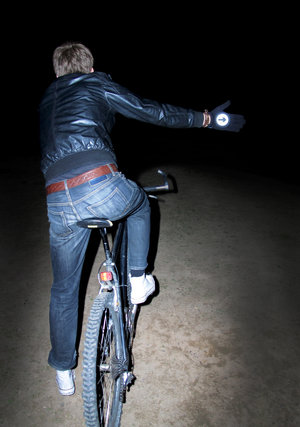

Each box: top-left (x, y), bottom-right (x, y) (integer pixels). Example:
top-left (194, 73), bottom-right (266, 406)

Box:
top-left (78, 170), bottom-right (169, 427)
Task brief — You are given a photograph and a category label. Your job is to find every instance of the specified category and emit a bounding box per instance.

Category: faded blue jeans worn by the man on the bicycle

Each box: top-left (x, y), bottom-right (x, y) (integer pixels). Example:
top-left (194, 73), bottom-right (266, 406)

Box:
top-left (47, 172), bottom-right (150, 370)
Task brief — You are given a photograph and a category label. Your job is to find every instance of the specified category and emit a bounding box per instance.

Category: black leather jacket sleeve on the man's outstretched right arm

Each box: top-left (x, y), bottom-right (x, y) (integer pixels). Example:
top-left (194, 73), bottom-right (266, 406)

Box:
top-left (105, 82), bottom-right (203, 128)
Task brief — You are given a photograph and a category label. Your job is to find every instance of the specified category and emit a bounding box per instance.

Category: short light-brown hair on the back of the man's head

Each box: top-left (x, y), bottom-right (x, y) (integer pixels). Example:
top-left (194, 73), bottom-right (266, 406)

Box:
top-left (53, 42), bottom-right (94, 77)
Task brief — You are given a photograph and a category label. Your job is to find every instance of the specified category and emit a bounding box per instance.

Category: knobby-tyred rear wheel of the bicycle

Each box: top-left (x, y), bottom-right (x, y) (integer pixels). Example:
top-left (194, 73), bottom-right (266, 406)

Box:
top-left (82, 292), bottom-right (123, 427)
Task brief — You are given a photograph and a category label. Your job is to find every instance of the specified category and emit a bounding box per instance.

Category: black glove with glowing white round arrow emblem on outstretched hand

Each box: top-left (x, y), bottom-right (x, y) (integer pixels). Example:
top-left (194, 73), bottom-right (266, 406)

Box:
top-left (207, 101), bottom-right (246, 132)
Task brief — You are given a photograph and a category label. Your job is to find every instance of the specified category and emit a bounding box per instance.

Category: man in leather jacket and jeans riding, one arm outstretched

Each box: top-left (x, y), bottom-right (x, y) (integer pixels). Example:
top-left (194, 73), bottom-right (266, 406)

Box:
top-left (40, 42), bottom-right (244, 395)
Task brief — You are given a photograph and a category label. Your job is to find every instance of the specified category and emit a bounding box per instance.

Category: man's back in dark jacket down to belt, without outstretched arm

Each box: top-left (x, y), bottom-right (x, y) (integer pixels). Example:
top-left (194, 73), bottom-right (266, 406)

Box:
top-left (40, 73), bottom-right (116, 185)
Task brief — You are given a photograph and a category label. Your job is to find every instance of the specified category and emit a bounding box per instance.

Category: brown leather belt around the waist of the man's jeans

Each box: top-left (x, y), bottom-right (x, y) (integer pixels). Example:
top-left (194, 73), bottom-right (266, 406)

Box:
top-left (46, 163), bottom-right (118, 195)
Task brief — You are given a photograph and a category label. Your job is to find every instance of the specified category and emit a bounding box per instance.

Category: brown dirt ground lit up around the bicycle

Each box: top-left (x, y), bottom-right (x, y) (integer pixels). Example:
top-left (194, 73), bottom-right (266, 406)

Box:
top-left (0, 159), bottom-right (300, 427)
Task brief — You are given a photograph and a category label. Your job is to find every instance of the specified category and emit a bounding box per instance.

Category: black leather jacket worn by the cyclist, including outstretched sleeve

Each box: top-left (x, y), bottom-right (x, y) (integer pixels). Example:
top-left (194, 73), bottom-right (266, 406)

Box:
top-left (40, 72), bottom-right (203, 174)
